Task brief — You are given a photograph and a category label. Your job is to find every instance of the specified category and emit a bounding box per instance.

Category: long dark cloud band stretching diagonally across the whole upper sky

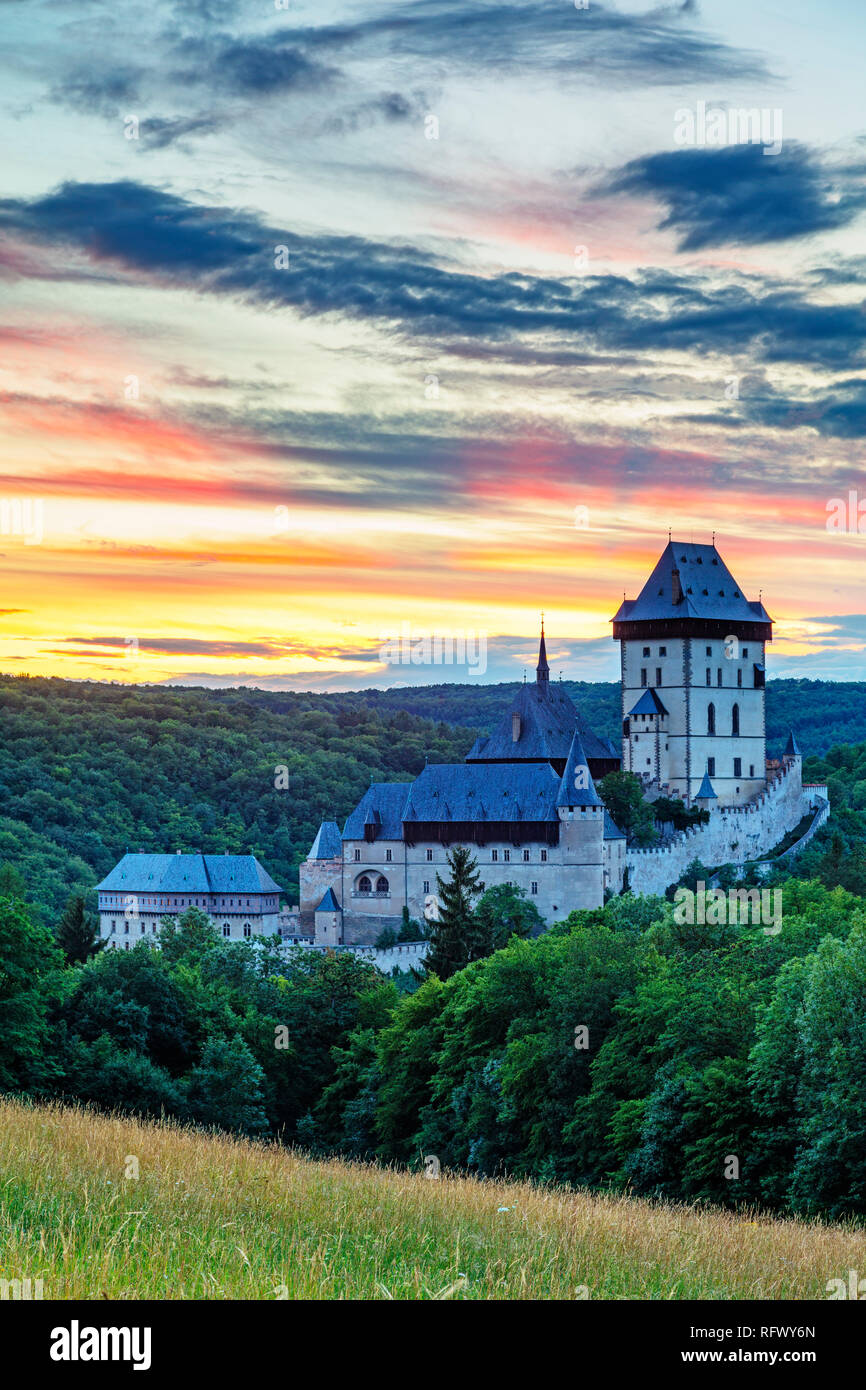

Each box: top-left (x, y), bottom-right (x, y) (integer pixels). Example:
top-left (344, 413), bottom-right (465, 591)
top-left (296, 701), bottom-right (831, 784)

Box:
top-left (0, 181), bottom-right (866, 378)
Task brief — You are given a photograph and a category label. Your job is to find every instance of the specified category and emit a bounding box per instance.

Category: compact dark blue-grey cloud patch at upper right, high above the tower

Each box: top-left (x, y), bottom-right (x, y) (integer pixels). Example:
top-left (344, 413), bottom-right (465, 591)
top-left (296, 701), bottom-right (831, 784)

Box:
top-left (603, 142), bottom-right (866, 250)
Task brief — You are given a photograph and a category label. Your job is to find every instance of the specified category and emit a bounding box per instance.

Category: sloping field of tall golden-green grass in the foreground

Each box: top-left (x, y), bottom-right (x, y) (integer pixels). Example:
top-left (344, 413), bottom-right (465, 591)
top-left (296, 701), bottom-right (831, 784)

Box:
top-left (0, 1099), bottom-right (866, 1300)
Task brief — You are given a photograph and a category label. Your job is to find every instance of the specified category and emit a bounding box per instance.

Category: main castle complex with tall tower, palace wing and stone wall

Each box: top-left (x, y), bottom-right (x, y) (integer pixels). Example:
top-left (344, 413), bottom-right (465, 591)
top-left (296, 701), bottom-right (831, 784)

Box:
top-left (300, 541), bottom-right (827, 945)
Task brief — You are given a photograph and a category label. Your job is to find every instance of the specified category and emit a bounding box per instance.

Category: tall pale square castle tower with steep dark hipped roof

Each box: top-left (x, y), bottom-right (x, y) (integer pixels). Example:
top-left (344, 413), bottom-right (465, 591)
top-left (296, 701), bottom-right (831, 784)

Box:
top-left (613, 541), bottom-right (773, 806)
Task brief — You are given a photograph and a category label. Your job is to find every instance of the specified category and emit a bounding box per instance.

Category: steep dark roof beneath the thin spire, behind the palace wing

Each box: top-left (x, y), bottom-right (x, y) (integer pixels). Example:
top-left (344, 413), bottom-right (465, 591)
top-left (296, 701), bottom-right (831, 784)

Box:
top-left (466, 681), bottom-right (620, 763)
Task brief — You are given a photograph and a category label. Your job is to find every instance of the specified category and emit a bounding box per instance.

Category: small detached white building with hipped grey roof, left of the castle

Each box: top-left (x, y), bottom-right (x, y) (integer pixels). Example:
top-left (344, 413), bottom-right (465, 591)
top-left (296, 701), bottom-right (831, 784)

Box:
top-left (96, 849), bottom-right (282, 951)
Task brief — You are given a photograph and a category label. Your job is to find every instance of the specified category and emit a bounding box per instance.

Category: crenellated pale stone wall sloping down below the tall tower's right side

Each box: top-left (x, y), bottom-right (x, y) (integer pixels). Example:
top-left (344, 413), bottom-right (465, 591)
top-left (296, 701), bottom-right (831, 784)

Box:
top-left (626, 758), bottom-right (817, 894)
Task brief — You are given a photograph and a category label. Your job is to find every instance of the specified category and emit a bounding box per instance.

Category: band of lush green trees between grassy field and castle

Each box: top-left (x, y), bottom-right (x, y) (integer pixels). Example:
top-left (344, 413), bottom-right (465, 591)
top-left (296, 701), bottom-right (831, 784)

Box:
top-left (0, 878), bottom-right (866, 1218)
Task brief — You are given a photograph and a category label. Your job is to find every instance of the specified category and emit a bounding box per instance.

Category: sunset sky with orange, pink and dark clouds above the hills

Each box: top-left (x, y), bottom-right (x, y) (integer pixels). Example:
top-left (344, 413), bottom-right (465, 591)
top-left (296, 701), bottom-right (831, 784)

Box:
top-left (0, 0), bottom-right (866, 691)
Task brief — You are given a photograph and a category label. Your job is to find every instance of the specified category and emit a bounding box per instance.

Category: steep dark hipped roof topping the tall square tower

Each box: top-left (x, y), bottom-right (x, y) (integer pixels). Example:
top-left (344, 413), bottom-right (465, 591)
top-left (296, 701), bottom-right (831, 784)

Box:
top-left (613, 541), bottom-right (770, 623)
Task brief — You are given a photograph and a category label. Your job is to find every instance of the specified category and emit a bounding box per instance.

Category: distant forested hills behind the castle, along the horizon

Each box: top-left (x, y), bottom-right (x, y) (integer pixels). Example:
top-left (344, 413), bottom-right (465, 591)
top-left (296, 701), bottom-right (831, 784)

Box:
top-left (0, 676), bottom-right (866, 919)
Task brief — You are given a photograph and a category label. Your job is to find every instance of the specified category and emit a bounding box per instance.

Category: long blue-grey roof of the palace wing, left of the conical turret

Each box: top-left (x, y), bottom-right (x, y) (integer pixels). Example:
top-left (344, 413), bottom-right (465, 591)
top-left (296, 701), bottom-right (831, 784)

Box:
top-left (405, 763), bottom-right (559, 823)
